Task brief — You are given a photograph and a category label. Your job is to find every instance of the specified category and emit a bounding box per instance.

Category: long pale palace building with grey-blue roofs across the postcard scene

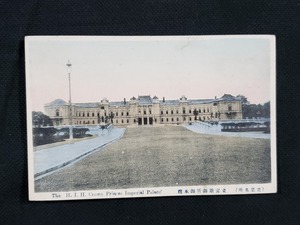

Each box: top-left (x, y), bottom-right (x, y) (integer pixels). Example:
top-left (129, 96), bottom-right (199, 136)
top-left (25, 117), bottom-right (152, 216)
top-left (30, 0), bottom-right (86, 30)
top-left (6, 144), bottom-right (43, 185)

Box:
top-left (45, 94), bottom-right (242, 126)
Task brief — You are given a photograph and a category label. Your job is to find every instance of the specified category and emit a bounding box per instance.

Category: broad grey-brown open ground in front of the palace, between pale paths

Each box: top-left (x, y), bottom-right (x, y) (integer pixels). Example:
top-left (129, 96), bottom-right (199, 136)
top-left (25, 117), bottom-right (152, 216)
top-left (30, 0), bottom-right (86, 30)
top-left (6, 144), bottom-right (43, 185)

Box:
top-left (35, 126), bottom-right (271, 192)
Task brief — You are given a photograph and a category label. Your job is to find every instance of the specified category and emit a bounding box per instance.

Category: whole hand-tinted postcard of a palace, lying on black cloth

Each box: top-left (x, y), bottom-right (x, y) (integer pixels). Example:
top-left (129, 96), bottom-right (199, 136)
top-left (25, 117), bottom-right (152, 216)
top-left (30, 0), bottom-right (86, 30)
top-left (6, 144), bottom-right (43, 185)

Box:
top-left (25, 35), bottom-right (277, 201)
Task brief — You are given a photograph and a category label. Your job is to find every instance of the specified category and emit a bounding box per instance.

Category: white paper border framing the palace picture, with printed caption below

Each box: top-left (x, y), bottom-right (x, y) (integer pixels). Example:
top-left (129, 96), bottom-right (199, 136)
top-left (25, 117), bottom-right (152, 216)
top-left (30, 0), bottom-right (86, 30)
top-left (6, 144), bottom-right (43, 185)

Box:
top-left (25, 35), bottom-right (277, 201)
